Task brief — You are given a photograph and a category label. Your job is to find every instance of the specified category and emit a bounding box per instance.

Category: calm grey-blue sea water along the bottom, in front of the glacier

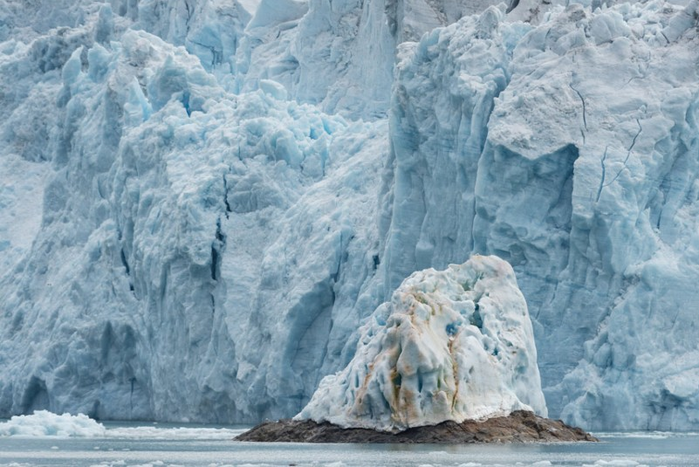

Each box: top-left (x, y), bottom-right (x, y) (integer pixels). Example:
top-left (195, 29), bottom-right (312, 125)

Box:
top-left (0, 424), bottom-right (699, 467)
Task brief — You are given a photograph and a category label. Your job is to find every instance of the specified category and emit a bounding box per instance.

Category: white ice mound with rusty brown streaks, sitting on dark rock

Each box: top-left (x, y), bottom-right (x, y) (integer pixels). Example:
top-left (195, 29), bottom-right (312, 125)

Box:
top-left (296, 256), bottom-right (546, 431)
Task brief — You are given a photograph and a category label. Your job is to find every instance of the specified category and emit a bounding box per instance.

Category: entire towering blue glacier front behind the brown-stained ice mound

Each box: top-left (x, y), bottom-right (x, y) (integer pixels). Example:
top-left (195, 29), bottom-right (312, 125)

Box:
top-left (0, 0), bottom-right (699, 430)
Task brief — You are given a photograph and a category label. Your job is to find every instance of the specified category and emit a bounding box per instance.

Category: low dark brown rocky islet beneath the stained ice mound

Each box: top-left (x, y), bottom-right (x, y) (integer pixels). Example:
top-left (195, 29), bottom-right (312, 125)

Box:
top-left (236, 410), bottom-right (598, 444)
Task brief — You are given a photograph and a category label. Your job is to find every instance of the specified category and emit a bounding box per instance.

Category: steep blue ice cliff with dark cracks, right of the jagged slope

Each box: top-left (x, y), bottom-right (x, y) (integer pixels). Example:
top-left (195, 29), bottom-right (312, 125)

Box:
top-left (385, 3), bottom-right (699, 429)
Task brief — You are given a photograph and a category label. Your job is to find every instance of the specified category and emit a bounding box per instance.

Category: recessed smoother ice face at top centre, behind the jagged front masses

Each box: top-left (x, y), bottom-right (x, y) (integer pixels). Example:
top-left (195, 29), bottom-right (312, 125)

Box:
top-left (232, 0), bottom-right (500, 119)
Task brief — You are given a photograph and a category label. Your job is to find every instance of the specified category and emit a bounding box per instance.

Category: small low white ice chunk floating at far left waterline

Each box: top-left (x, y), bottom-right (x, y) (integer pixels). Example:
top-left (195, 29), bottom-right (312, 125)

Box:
top-left (0, 410), bottom-right (107, 438)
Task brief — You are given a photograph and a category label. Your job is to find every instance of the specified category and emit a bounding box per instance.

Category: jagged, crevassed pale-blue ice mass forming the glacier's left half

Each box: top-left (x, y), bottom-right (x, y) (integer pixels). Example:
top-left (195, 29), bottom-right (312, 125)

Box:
top-left (0, 0), bottom-right (388, 422)
